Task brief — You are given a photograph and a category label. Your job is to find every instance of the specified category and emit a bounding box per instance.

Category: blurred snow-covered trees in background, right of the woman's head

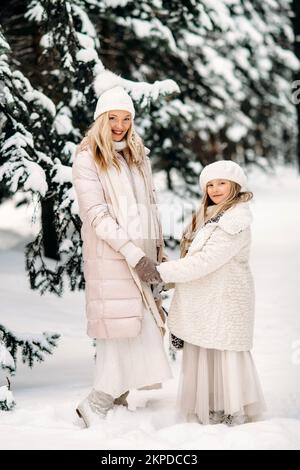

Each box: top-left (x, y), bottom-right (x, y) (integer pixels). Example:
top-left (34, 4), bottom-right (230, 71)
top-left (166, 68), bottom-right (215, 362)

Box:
top-left (87, 0), bottom-right (299, 191)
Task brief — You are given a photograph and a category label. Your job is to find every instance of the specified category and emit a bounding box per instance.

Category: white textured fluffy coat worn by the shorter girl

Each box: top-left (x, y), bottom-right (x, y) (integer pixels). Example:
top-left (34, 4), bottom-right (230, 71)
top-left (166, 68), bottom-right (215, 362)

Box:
top-left (158, 202), bottom-right (254, 351)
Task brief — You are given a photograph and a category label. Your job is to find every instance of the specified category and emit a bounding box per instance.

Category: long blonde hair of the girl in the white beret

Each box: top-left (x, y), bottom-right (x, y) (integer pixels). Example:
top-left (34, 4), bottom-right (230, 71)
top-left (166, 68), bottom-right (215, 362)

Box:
top-left (180, 181), bottom-right (253, 258)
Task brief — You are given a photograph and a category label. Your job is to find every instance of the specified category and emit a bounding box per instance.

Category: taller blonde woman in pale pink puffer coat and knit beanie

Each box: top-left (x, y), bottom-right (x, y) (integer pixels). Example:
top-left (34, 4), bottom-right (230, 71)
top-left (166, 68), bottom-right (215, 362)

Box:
top-left (72, 82), bottom-right (171, 426)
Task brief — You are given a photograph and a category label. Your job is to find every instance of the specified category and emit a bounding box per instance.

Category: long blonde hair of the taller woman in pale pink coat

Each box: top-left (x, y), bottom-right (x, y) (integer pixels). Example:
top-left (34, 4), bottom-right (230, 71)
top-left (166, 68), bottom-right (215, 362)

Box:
top-left (76, 111), bottom-right (145, 171)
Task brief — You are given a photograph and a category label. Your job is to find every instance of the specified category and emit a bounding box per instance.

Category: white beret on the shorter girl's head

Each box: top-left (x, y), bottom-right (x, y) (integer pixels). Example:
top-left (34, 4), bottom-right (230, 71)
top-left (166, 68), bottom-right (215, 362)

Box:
top-left (199, 160), bottom-right (247, 193)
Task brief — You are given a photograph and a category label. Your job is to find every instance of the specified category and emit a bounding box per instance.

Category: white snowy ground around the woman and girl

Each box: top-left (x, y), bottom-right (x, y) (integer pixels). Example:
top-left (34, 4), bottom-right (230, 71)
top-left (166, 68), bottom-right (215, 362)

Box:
top-left (0, 164), bottom-right (300, 449)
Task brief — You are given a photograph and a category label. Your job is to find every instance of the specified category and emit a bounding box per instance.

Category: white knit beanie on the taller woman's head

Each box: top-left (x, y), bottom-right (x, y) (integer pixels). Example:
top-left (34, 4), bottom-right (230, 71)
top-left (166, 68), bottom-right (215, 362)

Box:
top-left (94, 86), bottom-right (135, 120)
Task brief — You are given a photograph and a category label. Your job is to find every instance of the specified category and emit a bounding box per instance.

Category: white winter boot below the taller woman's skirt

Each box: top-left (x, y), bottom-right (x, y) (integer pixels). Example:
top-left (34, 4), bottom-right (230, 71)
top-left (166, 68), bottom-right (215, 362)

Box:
top-left (76, 389), bottom-right (114, 428)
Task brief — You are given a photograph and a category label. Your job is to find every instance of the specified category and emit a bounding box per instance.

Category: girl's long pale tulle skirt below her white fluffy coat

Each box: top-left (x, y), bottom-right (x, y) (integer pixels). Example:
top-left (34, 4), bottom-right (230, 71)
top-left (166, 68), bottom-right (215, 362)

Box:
top-left (178, 342), bottom-right (266, 424)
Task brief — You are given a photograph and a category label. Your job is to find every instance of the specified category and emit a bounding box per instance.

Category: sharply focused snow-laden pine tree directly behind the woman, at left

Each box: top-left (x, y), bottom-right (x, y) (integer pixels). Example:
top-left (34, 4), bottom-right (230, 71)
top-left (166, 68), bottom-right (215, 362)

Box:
top-left (0, 0), bottom-right (178, 295)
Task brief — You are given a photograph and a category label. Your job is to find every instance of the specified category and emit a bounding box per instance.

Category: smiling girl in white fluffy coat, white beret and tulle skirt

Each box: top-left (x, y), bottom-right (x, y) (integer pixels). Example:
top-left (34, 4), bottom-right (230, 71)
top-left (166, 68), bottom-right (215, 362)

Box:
top-left (157, 160), bottom-right (264, 424)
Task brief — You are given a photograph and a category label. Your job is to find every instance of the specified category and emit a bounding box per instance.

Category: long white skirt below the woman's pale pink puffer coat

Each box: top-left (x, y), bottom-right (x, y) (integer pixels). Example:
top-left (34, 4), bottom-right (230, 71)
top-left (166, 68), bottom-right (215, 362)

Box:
top-left (94, 308), bottom-right (172, 398)
